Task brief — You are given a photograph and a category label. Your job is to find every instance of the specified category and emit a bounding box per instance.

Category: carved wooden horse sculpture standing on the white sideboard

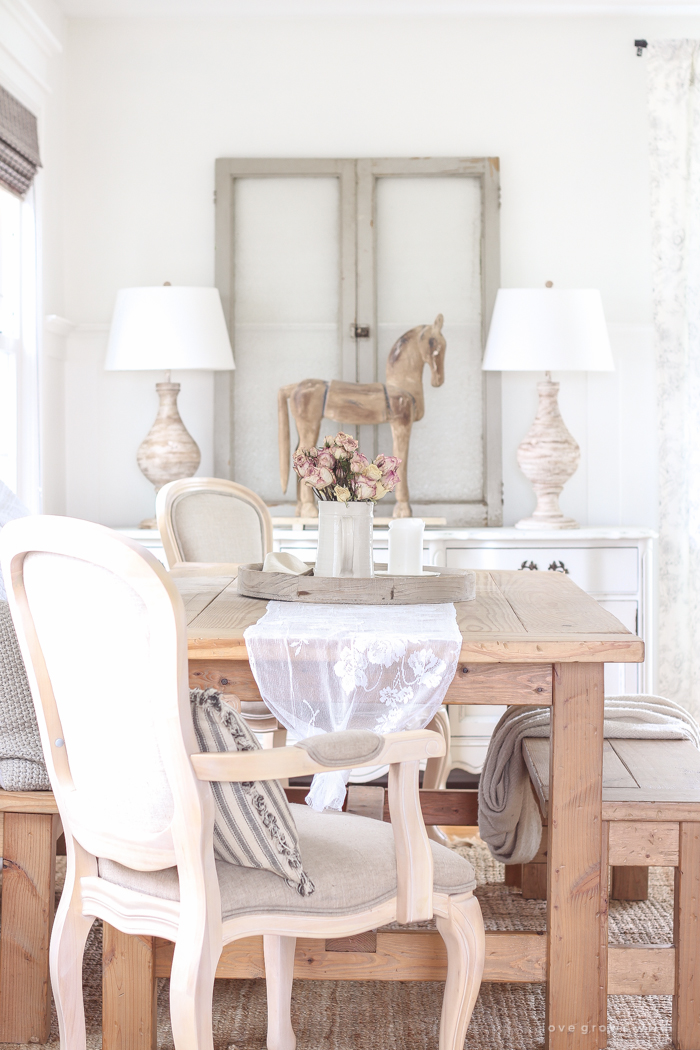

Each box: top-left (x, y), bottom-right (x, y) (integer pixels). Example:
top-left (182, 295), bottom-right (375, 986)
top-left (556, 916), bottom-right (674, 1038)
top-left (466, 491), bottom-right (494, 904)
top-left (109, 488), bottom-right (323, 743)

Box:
top-left (277, 314), bottom-right (447, 518)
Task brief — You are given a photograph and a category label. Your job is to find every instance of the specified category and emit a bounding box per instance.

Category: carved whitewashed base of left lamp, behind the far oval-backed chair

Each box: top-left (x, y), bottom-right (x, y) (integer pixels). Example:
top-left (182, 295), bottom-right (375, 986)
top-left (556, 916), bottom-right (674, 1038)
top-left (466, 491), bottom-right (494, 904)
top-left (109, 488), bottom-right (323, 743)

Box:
top-left (136, 373), bottom-right (201, 528)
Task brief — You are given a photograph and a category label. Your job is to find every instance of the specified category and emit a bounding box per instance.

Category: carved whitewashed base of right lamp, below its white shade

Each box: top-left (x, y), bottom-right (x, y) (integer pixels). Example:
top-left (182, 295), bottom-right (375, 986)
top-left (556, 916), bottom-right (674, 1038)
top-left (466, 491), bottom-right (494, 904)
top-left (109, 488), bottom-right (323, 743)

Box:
top-left (515, 373), bottom-right (580, 529)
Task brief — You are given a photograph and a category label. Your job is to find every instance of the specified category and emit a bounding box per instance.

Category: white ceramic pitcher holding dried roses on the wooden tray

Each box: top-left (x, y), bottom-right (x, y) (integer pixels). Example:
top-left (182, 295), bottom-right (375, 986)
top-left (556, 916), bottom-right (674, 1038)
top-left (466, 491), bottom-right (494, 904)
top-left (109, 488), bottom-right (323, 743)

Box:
top-left (314, 501), bottom-right (375, 578)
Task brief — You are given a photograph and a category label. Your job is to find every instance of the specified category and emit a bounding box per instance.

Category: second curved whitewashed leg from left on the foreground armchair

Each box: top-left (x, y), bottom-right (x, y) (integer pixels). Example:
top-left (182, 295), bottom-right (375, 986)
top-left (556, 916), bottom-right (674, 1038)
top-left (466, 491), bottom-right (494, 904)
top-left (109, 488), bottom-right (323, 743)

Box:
top-left (170, 919), bottom-right (220, 1050)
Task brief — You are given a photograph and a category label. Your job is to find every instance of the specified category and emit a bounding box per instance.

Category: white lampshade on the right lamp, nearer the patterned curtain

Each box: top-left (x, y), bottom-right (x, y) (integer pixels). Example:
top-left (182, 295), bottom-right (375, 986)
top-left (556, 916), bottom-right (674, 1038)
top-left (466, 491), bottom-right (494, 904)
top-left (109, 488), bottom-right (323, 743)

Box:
top-left (482, 288), bottom-right (615, 372)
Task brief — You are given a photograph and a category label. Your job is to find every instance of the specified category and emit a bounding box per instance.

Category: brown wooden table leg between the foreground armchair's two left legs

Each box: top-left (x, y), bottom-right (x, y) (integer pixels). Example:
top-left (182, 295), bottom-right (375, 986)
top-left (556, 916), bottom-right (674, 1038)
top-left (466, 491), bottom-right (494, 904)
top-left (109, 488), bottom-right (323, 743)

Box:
top-left (102, 923), bottom-right (157, 1050)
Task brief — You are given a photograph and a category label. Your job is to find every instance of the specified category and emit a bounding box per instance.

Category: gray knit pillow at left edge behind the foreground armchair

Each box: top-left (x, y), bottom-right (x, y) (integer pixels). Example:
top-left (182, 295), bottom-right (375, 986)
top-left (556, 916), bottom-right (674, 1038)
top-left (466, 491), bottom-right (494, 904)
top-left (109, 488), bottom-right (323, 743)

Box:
top-left (0, 602), bottom-right (51, 791)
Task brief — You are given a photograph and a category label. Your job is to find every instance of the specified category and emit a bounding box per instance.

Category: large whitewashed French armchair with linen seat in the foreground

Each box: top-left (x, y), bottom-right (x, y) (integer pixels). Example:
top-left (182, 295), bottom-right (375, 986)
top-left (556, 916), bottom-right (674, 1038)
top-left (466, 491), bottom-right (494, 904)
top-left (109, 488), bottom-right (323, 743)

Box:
top-left (0, 517), bottom-right (484, 1050)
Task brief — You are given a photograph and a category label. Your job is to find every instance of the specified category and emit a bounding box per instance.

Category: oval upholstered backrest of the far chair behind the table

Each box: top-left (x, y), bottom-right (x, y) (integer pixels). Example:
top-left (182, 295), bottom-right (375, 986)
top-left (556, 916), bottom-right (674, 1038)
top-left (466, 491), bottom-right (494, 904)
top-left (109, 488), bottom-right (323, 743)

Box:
top-left (155, 478), bottom-right (272, 568)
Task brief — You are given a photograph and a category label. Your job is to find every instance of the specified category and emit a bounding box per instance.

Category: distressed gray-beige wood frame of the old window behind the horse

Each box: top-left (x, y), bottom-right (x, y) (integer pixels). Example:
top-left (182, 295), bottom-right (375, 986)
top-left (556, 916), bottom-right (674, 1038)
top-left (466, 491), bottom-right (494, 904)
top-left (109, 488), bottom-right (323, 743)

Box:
top-left (214, 158), bottom-right (503, 525)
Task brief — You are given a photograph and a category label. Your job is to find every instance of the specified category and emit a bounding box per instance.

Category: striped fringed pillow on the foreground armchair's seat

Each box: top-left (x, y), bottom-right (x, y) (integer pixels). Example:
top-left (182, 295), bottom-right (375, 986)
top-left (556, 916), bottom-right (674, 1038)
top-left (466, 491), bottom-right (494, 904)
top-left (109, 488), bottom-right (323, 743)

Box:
top-left (190, 689), bottom-right (314, 897)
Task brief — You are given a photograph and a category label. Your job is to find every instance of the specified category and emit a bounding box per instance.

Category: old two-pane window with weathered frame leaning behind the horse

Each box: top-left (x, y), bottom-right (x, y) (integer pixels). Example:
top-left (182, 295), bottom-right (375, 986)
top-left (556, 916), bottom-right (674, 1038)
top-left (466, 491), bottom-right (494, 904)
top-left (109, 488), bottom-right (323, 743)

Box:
top-left (215, 159), bottom-right (502, 525)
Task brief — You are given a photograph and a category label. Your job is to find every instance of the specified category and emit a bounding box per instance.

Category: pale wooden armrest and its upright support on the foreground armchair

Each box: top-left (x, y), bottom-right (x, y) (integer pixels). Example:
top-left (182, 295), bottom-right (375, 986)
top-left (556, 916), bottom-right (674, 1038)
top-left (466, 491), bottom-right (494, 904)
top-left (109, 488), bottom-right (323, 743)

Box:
top-left (191, 729), bottom-right (445, 923)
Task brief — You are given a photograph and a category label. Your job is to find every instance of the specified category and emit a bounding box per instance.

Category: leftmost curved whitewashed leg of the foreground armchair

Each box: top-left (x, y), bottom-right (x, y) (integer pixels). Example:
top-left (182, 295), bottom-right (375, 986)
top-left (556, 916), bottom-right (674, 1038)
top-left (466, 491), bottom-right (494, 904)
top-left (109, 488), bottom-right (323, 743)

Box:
top-left (49, 837), bottom-right (97, 1050)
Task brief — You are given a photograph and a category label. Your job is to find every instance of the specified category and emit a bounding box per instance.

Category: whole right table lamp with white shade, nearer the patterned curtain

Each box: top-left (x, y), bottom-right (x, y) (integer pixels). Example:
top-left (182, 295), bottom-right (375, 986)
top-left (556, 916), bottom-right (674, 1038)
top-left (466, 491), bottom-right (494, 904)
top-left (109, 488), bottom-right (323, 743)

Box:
top-left (482, 281), bottom-right (615, 529)
